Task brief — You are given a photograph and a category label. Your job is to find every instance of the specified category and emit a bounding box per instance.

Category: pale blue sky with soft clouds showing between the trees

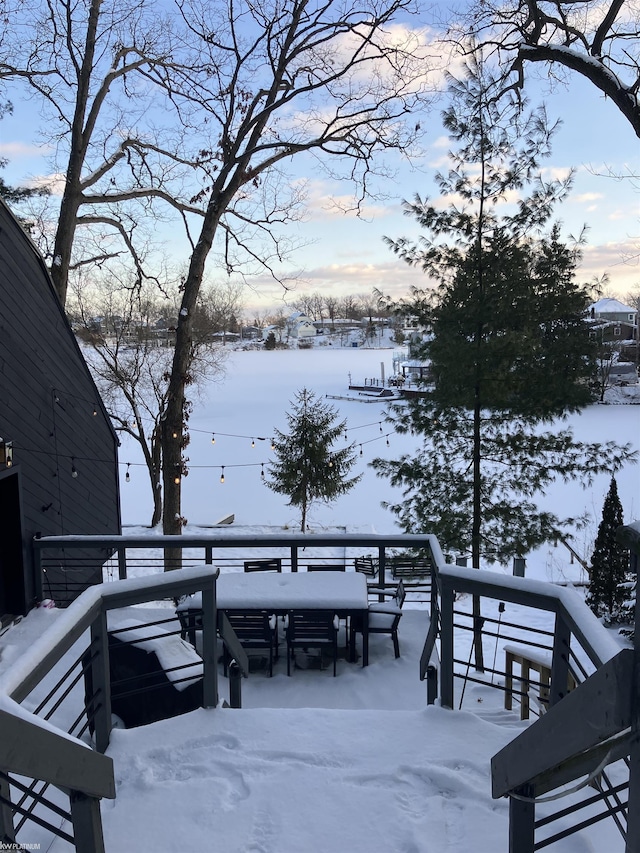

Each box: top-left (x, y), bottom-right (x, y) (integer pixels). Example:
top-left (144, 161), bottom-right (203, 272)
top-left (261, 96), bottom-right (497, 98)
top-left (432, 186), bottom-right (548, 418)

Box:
top-left (0, 7), bottom-right (640, 314)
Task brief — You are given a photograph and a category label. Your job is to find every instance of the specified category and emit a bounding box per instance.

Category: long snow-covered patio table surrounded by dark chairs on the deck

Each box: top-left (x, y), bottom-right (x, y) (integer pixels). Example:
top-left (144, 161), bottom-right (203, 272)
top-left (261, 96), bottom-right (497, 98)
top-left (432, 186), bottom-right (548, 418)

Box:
top-left (177, 572), bottom-right (369, 666)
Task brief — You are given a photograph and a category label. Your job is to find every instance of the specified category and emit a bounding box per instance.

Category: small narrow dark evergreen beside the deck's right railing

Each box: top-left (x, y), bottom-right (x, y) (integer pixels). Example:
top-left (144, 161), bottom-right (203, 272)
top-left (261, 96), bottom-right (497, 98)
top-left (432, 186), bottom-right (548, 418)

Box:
top-left (587, 477), bottom-right (629, 621)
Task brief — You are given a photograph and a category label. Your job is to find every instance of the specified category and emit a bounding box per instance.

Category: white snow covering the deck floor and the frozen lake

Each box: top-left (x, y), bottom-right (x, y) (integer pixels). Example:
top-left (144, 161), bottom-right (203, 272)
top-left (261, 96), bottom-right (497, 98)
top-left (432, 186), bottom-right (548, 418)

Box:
top-left (0, 348), bottom-right (640, 853)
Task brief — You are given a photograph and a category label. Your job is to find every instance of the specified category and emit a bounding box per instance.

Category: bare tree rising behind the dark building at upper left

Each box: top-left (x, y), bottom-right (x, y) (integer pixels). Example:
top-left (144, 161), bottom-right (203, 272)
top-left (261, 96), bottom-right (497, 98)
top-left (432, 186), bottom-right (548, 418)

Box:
top-left (0, 0), bottom-right (200, 305)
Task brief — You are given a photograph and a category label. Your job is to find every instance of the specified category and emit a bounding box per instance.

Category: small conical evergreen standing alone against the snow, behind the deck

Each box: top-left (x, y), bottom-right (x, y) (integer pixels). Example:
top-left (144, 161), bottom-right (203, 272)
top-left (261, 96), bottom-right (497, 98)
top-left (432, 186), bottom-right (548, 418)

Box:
top-left (266, 388), bottom-right (361, 533)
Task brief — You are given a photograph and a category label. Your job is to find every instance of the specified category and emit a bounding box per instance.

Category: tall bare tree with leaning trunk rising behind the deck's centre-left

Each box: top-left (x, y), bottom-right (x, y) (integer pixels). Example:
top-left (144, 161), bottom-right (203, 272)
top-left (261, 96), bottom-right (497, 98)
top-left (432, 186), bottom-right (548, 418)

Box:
top-left (162, 0), bottom-right (436, 534)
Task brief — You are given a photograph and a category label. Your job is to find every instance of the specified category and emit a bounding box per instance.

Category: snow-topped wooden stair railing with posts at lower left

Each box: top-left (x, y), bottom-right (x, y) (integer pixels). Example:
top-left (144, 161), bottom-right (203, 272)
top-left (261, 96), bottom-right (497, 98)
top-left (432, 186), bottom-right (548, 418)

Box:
top-left (0, 566), bottom-right (218, 853)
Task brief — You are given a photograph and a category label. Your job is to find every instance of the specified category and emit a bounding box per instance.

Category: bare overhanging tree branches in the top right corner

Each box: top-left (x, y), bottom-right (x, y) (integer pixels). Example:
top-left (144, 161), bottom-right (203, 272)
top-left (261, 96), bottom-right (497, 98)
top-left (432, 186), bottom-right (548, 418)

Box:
top-left (454, 0), bottom-right (640, 137)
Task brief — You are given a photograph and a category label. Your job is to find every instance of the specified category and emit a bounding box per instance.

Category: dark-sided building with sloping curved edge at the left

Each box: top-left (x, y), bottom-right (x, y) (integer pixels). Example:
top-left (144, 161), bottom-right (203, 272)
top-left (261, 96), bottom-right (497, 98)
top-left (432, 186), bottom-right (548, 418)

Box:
top-left (0, 200), bottom-right (121, 620)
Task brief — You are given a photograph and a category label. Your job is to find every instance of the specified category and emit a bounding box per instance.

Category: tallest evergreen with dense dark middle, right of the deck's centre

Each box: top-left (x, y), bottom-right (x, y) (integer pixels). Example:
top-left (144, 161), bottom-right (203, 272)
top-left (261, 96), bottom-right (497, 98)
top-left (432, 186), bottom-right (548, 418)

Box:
top-left (373, 60), bottom-right (631, 584)
